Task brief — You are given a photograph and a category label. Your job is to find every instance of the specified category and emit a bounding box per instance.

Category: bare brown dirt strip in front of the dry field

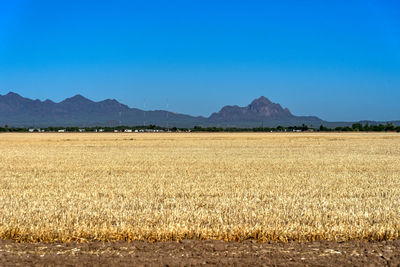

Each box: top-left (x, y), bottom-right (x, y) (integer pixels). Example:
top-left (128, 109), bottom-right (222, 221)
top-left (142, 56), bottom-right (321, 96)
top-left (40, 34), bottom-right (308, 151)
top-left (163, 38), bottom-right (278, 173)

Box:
top-left (0, 240), bottom-right (400, 266)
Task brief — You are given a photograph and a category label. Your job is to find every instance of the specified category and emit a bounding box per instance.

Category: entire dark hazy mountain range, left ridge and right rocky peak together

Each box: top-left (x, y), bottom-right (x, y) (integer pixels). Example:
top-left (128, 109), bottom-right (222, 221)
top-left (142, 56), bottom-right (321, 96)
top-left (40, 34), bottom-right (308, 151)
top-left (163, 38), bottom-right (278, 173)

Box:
top-left (0, 92), bottom-right (396, 127)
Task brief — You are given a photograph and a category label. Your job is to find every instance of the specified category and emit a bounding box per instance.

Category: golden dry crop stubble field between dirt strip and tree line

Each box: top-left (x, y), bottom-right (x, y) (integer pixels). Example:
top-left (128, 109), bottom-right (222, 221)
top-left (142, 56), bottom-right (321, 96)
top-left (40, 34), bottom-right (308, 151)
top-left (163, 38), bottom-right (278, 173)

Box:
top-left (0, 133), bottom-right (400, 242)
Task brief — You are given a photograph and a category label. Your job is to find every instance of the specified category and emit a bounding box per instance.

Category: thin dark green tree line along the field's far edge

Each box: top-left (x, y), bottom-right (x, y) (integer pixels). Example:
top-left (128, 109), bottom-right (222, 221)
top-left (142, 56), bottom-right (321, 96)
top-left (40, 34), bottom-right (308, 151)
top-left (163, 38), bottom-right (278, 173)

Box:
top-left (0, 123), bottom-right (400, 132)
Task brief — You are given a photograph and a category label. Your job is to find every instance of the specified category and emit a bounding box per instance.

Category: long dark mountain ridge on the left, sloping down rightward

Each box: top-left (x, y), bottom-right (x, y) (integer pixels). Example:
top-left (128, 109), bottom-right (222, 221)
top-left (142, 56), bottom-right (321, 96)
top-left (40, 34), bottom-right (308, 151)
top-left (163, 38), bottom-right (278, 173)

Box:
top-left (0, 92), bottom-right (205, 127)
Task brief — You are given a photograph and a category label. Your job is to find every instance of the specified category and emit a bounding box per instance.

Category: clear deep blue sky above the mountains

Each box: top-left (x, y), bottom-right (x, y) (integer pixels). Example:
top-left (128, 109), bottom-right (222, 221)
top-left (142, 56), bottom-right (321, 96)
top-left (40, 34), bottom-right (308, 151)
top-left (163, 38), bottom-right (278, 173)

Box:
top-left (0, 0), bottom-right (400, 121)
